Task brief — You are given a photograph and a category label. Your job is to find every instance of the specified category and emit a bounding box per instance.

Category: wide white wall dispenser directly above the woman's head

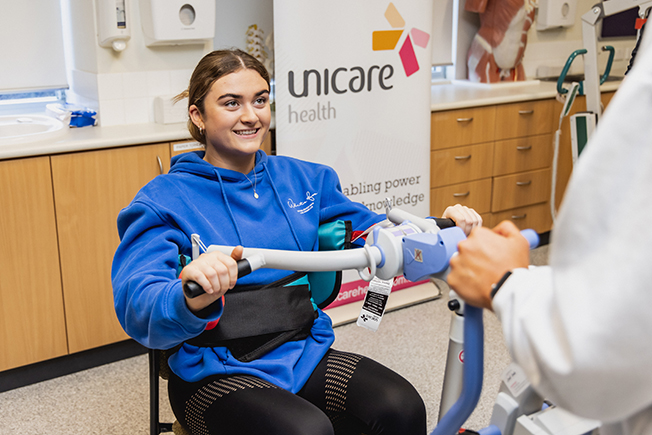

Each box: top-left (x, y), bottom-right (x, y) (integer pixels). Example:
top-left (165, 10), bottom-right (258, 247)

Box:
top-left (139, 0), bottom-right (215, 46)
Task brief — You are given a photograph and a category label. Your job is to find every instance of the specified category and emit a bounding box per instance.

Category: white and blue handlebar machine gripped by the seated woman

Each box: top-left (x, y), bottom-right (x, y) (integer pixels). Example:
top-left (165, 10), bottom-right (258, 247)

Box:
top-left (184, 205), bottom-right (556, 435)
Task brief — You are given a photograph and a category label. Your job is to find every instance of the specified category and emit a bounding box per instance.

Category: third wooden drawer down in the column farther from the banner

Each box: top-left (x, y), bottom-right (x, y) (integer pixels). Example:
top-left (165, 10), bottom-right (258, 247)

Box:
top-left (491, 169), bottom-right (551, 212)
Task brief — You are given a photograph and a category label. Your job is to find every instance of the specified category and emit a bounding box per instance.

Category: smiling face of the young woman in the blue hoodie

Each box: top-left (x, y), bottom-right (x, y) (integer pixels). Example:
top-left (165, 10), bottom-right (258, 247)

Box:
top-left (189, 69), bottom-right (271, 173)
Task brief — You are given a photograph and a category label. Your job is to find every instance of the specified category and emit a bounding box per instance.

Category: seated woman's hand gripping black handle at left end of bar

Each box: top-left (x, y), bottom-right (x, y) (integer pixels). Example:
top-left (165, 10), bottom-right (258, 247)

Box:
top-left (181, 246), bottom-right (244, 312)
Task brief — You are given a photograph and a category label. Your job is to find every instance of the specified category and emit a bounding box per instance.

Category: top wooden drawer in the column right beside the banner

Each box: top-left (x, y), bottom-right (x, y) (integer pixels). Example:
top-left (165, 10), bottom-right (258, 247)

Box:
top-left (430, 106), bottom-right (496, 150)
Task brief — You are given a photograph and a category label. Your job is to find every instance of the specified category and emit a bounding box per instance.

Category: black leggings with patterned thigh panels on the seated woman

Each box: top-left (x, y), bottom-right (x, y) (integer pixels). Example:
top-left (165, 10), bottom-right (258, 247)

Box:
top-left (168, 349), bottom-right (426, 435)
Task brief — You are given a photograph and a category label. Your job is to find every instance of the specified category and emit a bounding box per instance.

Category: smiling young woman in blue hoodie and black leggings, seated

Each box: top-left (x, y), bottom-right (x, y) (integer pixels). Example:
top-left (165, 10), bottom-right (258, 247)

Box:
top-left (112, 50), bottom-right (481, 435)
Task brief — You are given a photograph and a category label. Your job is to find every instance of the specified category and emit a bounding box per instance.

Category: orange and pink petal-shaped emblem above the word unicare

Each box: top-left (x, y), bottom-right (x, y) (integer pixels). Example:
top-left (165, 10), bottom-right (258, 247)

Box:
top-left (372, 2), bottom-right (430, 77)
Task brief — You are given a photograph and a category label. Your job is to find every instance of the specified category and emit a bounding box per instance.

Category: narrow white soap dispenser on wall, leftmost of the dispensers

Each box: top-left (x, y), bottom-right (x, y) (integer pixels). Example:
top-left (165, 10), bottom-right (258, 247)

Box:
top-left (95, 0), bottom-right (131, 51)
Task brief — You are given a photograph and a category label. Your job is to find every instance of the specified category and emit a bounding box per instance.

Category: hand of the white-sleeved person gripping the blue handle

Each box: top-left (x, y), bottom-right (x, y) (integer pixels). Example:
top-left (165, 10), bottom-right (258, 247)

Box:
top-left (447, 221), bottom-right (530, 309)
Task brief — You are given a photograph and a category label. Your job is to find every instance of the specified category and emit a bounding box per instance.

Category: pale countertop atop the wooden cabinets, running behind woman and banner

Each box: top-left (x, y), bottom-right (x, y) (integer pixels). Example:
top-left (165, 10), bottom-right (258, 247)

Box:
top-left (0, 82), bottom-right (620, 160)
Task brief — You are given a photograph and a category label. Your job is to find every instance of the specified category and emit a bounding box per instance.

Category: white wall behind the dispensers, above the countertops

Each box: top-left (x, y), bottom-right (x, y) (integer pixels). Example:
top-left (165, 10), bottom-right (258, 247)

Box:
top-left (38, 0), bottom-right (634, 125)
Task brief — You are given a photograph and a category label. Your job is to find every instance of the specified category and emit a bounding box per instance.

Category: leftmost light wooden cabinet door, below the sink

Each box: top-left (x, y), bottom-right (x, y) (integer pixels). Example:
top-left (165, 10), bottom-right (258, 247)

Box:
top-left (0, 157), bottom-right (68, 371)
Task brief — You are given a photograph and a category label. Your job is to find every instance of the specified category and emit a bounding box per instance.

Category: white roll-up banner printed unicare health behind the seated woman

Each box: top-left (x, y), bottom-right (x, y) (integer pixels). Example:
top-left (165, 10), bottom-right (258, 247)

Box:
top-left (274, 0), bottom-right (432, 307)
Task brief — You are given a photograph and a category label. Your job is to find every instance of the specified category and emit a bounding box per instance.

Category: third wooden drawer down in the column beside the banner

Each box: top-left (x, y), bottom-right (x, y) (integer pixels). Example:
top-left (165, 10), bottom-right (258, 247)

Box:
top-left (430, 178), bottom-right (491, 216)
